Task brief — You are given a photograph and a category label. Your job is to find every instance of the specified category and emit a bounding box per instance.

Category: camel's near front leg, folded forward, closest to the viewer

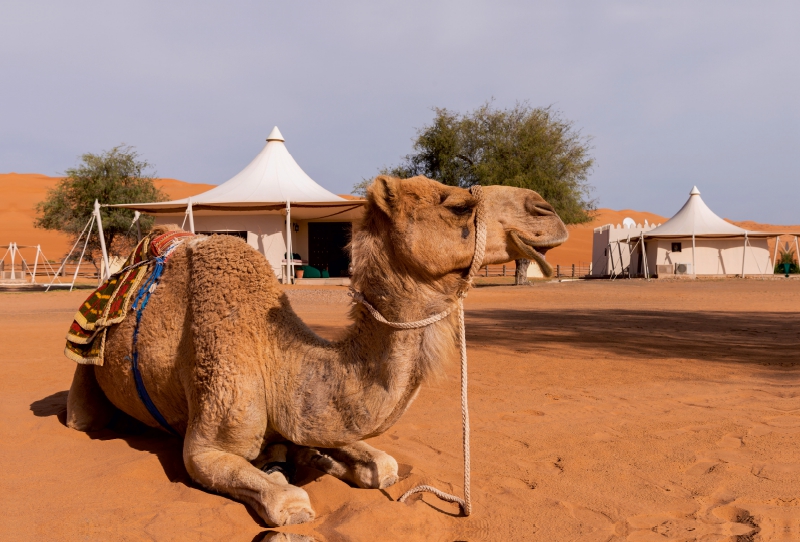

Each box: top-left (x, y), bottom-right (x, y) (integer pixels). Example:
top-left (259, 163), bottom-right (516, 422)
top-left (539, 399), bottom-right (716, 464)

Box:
top-left (183, 430), bottom-right (314, 526)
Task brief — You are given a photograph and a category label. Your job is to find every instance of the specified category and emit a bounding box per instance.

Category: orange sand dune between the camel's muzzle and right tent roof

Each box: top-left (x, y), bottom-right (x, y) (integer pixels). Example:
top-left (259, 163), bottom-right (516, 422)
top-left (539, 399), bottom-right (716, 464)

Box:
top-left (547, 209), bottom-right (667, 266)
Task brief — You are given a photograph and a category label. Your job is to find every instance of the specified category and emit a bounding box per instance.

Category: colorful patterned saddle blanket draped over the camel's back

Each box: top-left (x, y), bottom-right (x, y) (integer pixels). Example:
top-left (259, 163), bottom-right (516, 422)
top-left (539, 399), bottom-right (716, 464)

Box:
top-left (64, 231), bottom-right (194, 365)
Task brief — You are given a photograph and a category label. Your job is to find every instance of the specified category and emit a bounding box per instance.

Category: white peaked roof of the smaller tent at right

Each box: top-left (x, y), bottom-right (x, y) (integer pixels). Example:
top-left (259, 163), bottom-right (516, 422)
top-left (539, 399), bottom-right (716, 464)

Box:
top-left (644, 186), bottom-right (747, 237)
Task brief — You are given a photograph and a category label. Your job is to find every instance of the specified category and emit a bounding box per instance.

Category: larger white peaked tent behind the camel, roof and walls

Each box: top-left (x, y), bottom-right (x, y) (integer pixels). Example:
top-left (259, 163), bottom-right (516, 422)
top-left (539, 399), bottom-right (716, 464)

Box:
top-left (117, 126), bottom-right (365, 281)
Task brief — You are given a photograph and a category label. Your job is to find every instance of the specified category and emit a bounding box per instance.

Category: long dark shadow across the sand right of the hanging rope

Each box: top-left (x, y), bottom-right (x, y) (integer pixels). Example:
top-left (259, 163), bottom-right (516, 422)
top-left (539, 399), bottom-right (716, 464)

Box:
top-left (466, 309), bottom-right (800, 369)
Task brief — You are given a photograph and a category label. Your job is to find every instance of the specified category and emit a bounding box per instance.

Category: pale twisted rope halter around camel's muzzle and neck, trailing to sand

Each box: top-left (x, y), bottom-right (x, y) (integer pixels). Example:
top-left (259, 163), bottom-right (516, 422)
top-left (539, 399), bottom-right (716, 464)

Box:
top-left (348, 185), bottom-right (486, 516)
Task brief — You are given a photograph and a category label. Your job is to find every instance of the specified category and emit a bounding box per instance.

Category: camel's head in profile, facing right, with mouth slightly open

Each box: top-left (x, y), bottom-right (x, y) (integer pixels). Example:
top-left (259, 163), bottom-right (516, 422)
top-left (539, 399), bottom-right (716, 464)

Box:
top-left (356, 175), bottom-right (567, 278)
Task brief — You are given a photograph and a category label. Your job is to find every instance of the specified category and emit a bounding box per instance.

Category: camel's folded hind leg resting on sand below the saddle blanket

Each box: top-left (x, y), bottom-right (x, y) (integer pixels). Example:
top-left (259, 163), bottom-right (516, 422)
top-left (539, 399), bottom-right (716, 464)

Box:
top-left (67, 364), bottom-right (117, 431)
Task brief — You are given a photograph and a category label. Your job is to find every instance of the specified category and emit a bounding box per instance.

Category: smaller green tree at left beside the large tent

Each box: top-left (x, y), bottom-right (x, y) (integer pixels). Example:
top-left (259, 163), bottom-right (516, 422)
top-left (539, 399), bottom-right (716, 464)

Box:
top-left (34, 145), bottom-right (167, 266)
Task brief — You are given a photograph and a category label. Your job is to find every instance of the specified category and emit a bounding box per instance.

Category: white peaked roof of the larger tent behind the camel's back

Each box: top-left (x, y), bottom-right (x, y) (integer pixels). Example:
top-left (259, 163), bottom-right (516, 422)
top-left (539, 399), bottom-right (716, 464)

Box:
top-left (112, 126), bottom-right (364, 213)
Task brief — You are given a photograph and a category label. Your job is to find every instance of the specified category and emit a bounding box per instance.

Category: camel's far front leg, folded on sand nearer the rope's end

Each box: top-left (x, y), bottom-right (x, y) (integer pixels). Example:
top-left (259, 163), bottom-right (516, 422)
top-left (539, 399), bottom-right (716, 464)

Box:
top-left (290, 442), bottom-right (397, 489)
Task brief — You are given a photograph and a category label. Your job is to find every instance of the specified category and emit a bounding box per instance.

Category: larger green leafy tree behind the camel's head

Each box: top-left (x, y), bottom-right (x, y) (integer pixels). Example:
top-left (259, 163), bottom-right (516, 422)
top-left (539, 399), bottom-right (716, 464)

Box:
top-left (360, 102), bottom-right (596, 224)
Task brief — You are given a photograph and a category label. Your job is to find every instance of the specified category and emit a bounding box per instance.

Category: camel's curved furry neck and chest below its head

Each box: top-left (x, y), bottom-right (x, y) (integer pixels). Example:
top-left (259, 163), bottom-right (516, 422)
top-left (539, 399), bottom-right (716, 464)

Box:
top-left (270, 227), bottom-right (461, 446)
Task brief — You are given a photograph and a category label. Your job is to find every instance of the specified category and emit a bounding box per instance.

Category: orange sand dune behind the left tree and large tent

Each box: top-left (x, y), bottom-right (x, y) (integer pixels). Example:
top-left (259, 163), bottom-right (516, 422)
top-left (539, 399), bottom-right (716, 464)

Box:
top-left (0, 173), bottom-right (213, 260)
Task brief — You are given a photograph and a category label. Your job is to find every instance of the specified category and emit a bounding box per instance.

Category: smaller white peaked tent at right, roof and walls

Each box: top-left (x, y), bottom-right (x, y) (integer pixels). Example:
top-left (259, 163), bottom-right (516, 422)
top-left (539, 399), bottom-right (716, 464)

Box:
top-left (631, 186), bottom-right (796, 276)
